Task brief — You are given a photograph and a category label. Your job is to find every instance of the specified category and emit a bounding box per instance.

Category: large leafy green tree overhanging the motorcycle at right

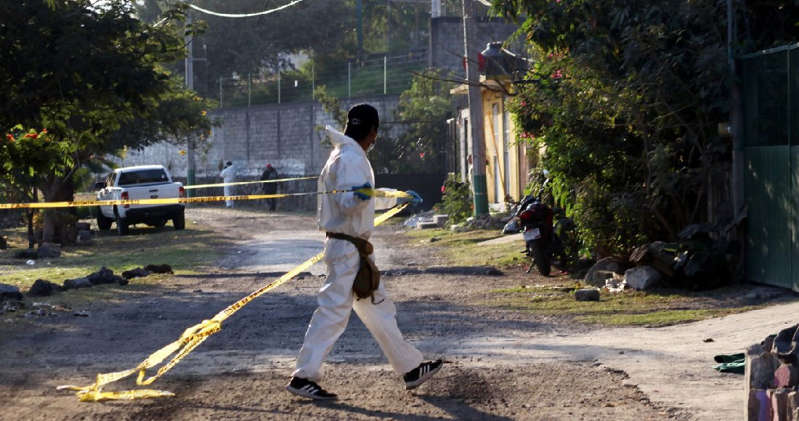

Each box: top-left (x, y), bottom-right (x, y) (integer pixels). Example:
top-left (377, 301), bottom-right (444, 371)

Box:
top-left (494, 0), bottom-right (799, 253)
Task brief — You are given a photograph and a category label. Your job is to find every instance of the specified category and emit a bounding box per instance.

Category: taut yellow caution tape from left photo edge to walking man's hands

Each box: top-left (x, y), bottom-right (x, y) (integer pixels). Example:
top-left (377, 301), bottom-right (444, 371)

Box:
top-left (0, 189), bottom-right (410, 209)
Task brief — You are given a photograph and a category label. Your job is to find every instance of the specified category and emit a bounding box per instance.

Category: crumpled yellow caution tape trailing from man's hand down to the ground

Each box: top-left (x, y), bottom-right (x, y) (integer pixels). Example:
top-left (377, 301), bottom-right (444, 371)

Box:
top-left (57, 203), bottom-right (408, 402)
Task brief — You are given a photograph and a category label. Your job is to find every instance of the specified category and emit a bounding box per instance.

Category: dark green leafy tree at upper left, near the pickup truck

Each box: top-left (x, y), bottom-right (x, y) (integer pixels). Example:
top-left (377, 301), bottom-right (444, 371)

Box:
top-left (0, 0), bottom-right (211, 240)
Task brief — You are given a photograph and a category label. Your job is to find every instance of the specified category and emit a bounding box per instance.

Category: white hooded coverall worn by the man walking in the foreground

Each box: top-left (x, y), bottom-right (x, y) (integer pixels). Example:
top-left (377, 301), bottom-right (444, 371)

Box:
top-left (292, 127), bottom-right (422, 382)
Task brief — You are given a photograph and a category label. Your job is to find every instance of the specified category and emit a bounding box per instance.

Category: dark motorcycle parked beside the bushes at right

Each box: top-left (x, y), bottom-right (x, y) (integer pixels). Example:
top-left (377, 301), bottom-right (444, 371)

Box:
top-left (503, 181), bottom-right (574, 276)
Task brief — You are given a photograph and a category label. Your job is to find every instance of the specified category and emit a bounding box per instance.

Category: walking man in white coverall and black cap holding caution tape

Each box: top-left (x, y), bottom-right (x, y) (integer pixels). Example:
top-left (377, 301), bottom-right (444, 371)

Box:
top-left (286, 104), bottom-right (443, 400)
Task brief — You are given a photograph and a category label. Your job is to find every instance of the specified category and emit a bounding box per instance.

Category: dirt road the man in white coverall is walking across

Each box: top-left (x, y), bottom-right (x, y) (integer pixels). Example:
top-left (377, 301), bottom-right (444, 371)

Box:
top-left (0, 209), bottom-right (776, 420)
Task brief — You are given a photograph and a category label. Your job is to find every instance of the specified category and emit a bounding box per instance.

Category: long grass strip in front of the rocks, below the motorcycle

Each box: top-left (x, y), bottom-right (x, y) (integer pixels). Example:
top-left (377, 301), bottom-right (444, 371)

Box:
top-left (488, 285), bottom-right (756, 327)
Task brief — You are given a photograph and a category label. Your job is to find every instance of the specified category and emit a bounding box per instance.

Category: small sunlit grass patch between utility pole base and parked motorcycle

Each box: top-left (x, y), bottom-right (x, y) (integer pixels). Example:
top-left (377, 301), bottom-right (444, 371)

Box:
top-left (406, 230), bottom-right (528, 267)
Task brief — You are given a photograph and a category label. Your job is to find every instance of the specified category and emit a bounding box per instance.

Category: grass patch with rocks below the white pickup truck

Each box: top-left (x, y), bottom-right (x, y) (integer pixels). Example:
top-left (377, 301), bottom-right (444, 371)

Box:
top-left (0, 221), bottom-right (230, 291)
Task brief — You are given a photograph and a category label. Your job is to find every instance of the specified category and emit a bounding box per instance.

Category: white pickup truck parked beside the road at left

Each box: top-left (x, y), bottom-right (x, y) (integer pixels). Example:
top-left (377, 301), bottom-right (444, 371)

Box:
top-left (95, 165), bottom-right (186, 235)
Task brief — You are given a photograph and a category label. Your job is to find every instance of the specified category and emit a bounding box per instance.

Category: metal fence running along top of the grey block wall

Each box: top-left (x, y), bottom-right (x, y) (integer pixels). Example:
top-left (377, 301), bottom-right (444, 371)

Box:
top-left (209, 52), bottom-right (427, 108)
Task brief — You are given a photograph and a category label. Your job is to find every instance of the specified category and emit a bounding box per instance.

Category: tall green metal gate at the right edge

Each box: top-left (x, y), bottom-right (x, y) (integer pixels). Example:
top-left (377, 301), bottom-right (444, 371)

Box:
top-left (739, 45), bottom-right (799, 291)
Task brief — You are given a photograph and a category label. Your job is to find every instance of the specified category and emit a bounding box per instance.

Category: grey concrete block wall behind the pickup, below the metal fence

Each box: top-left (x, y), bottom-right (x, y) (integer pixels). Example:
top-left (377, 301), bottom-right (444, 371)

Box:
top-left (117, 96), bottom-right (403, 210)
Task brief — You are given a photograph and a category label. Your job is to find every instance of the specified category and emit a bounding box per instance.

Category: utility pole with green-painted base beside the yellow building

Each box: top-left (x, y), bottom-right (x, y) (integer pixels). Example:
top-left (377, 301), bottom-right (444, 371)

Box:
top-left (462, 0), bottom-right (488, 216)
